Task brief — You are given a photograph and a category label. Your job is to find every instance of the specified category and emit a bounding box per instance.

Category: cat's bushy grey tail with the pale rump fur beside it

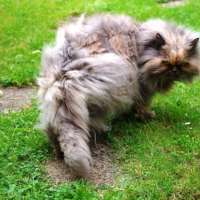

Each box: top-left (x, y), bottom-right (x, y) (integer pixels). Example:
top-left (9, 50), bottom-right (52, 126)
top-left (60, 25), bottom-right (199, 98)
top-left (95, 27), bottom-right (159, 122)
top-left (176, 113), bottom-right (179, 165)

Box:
top-left (37, 47), bottom-right (92, 178)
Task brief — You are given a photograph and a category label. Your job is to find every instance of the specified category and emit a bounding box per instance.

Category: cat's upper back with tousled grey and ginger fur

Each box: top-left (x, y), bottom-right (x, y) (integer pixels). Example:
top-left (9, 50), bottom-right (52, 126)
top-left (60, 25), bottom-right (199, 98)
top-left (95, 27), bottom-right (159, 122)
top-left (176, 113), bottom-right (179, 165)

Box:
top-left (57, 14), bottom-right (138, 62)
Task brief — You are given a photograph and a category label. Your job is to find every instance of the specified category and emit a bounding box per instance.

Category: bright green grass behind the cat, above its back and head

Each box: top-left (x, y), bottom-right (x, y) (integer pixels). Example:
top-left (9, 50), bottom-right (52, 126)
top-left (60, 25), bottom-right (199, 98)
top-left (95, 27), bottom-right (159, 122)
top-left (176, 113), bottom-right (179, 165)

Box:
top-left (0, 0), bottom-right (200, 86)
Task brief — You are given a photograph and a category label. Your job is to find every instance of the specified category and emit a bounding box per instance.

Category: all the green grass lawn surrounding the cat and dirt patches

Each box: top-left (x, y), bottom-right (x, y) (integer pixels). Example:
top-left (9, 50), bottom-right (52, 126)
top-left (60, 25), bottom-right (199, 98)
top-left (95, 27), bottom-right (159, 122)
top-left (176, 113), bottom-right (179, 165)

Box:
top-left (0, 0), bottom-right (200, 200)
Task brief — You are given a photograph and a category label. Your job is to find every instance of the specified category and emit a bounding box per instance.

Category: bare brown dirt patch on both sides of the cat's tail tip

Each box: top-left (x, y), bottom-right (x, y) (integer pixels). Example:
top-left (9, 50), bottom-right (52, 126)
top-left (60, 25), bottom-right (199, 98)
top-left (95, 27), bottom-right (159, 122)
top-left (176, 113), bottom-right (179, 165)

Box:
top-left (46, 143), bottom-right (115, 185)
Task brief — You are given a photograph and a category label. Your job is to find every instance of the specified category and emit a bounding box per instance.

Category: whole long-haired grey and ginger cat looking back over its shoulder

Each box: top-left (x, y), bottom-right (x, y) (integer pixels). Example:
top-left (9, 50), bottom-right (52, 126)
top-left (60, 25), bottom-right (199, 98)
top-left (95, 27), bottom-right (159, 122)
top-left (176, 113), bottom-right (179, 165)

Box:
top-left (37, 15), bottom-right (200, 178)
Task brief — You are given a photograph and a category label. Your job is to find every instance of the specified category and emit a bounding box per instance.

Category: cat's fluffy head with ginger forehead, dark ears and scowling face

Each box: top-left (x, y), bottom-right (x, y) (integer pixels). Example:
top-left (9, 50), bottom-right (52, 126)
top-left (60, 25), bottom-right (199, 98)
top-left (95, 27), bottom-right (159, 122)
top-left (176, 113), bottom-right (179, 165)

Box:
top-left (138, 20), bottom-right (200, 82)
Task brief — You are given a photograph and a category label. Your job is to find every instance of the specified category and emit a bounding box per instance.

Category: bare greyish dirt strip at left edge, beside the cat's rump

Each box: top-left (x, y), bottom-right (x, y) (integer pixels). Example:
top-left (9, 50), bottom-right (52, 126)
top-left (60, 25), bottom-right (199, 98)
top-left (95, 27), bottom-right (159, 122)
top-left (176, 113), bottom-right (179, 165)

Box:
top-left (0, 86), bottom-right (36, 113)
